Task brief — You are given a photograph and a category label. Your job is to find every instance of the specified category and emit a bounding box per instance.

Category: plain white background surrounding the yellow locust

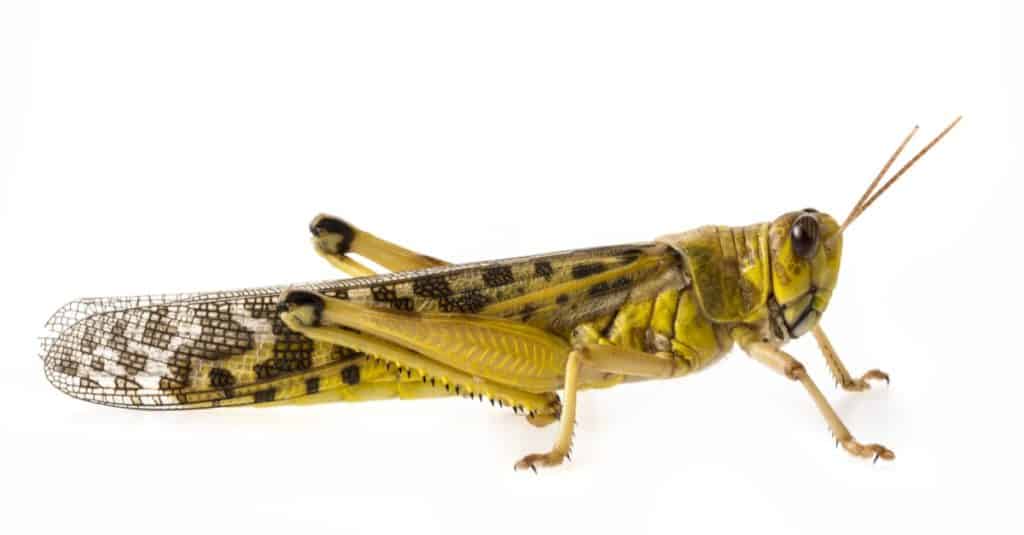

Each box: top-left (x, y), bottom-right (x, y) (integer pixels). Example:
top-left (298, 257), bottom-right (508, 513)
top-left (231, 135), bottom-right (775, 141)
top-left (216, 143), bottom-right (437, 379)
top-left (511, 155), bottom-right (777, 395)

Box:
top-left (0, 0), bottom-right (1024, 534)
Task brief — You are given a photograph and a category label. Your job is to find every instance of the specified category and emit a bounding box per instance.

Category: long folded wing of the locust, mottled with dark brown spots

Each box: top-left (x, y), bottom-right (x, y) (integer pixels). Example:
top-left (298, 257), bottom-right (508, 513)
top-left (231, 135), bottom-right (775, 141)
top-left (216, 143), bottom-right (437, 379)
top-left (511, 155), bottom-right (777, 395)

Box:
top-left (42, 244), bottom-right (680, 409)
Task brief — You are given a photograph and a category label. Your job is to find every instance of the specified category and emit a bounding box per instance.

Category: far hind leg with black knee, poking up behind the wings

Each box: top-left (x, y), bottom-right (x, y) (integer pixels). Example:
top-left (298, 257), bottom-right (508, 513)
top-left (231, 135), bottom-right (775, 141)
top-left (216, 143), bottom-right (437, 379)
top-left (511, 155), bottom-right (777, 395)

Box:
top-left (309, 214), bottom-right (447, 277)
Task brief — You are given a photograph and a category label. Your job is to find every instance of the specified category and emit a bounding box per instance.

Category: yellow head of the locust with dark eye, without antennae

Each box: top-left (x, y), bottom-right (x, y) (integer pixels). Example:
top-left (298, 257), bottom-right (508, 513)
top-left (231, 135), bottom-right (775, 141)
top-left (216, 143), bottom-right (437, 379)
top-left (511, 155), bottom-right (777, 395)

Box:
top-left (768, 208), bottom-right (843, 339)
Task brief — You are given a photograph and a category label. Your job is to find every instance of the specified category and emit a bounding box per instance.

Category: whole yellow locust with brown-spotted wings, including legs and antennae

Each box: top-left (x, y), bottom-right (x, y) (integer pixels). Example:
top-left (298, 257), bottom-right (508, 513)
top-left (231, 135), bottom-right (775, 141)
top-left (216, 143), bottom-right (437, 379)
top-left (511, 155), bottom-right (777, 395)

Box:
top-left (42, 119), bottom-right (958, 469)
